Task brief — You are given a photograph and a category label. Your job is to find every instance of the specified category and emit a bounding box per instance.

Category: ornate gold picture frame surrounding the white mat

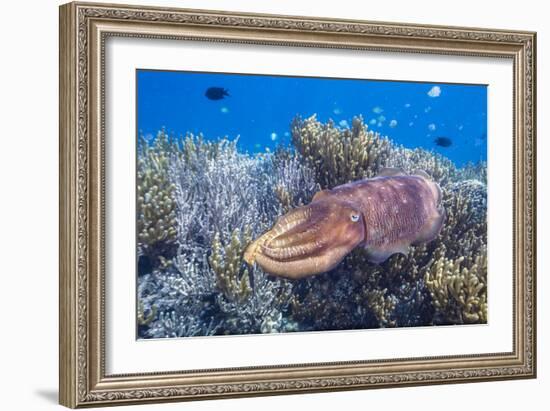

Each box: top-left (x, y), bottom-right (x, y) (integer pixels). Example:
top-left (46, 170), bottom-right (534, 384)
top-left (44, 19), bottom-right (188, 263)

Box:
top-left (59, 2), bottom-right (536, 408)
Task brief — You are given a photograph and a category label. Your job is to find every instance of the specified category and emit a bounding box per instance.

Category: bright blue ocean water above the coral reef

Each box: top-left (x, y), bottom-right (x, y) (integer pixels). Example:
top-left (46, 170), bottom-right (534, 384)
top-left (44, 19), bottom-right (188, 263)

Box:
top-left (136, 70), bottom-right (487, 166)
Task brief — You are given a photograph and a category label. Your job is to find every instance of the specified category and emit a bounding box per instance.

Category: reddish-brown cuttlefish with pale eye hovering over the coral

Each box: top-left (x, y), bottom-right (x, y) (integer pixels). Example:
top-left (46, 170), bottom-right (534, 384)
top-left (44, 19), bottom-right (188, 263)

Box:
top-left (244, 168), bottom-right (445, 279)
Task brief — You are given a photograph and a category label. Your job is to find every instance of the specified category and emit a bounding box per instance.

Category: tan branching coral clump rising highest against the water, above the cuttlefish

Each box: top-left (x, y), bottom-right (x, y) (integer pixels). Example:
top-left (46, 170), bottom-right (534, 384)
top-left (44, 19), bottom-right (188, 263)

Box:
top-left (292, 115), bottom-right (391, 189)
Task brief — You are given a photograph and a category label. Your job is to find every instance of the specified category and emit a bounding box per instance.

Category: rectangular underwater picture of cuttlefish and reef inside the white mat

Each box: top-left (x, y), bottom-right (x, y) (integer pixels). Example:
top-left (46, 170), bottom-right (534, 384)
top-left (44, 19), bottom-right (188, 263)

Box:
top-left (136, 69), bottom-right (488, 339)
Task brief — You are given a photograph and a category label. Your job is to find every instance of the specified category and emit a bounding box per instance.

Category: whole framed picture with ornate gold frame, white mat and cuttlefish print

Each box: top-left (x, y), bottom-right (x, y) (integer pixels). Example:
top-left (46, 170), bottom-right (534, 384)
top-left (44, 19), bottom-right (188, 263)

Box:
top-left (60, 3), bottom-right (536, 407)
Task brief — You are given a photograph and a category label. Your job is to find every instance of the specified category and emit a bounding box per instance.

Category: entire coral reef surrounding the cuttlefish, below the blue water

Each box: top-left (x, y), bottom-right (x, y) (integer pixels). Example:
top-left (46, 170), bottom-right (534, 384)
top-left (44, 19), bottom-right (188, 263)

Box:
top-left (136, 116), bottom-right (488, 338)
